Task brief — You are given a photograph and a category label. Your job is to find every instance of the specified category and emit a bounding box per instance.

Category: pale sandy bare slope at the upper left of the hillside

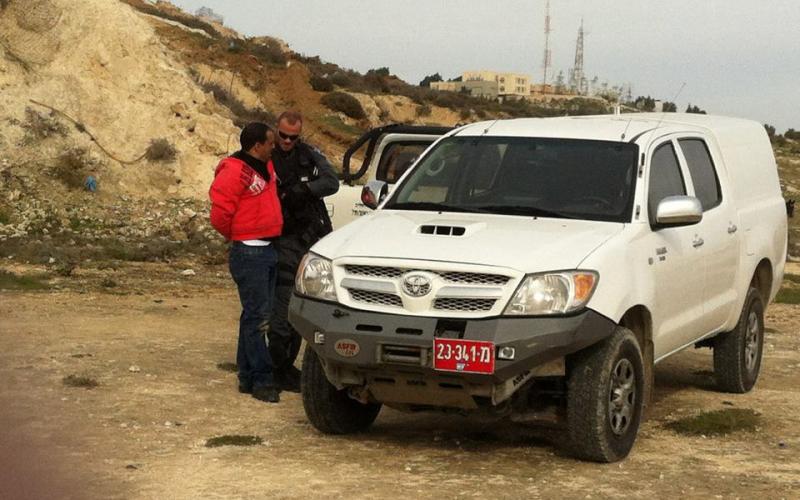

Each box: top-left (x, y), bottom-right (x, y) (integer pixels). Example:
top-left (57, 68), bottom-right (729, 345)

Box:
top-left (0, 0), bottom-right (236, 197)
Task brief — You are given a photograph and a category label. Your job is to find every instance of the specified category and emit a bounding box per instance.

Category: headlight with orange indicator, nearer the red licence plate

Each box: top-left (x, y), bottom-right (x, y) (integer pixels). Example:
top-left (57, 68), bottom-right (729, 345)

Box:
top-left (504, 271), bottom-right (598, 316)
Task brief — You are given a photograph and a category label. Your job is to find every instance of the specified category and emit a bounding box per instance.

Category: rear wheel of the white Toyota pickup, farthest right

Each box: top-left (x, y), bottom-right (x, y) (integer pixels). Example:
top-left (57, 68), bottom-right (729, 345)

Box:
top-left (714, 287), bottom-right (764, 394)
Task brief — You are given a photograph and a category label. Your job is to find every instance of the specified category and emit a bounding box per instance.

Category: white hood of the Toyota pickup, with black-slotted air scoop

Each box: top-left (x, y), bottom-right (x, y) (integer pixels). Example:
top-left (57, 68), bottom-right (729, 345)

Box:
top-left (312, 210), bottom-right (624, 273)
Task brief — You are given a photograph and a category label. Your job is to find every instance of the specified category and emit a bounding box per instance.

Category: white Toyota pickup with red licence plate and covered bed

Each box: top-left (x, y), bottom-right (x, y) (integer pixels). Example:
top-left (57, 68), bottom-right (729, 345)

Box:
top-left (290, 113), bottom-right (787, 462)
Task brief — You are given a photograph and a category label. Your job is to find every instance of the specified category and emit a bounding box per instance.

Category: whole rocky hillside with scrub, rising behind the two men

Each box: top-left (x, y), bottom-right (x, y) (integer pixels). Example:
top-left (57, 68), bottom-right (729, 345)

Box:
top-left (0, 0), bottom-right (797, 268)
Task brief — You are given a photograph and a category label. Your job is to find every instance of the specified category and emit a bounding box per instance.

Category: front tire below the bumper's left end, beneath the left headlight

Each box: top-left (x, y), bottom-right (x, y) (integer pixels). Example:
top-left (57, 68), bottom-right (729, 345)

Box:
top-left (300, 346), bottom-right (381, 434)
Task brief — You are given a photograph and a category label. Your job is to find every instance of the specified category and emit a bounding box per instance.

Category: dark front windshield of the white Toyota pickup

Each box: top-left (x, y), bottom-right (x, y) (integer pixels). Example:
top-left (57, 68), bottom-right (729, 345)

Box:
top-left (384, 137), bottom-right (638, 222)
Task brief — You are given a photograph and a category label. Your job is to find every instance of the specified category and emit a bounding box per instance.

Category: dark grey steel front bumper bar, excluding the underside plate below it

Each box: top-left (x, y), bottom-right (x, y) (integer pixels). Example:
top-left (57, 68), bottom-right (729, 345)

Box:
top-left (289, 295), bottom-right (617, 384)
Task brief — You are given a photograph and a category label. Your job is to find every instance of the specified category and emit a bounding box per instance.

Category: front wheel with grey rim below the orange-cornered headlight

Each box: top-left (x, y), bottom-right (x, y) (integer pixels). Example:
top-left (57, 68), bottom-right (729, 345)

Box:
top-left (567, 326), bottom-right (645, 462)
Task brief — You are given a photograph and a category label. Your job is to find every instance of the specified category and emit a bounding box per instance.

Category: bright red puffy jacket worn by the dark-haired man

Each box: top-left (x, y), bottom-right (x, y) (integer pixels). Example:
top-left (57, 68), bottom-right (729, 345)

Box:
top-left (208, 156), bottom-right (283, 241)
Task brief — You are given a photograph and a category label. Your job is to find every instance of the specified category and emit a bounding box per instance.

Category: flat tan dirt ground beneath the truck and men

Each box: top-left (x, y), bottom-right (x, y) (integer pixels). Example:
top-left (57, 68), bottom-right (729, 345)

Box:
top-left (0, 264), bottom-right (800, 499)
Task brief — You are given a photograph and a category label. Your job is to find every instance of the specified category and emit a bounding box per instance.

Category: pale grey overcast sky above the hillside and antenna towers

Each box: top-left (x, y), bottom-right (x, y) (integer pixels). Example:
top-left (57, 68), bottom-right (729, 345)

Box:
top-left (166, 0), bottom-right (800, 133)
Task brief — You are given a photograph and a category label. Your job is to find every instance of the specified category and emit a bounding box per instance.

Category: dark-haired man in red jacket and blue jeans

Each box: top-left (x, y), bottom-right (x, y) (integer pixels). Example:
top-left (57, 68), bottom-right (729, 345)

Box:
top-left (209, 123), bottom-right (283, 403)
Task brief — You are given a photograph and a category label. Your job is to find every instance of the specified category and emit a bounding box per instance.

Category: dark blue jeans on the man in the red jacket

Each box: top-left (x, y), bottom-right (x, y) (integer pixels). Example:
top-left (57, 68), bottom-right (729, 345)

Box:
top-left (229, 241), bottom-right (278, 388)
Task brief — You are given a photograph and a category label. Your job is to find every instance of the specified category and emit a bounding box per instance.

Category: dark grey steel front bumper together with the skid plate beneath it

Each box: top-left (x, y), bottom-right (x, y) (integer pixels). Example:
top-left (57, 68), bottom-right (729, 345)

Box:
top-left (289, 295), bottom-right (617, 409)
